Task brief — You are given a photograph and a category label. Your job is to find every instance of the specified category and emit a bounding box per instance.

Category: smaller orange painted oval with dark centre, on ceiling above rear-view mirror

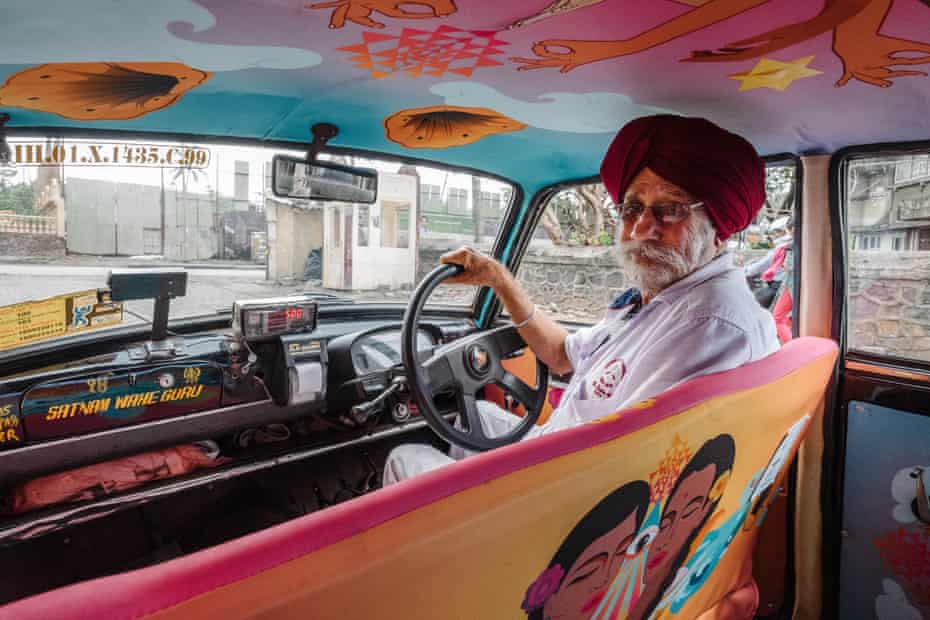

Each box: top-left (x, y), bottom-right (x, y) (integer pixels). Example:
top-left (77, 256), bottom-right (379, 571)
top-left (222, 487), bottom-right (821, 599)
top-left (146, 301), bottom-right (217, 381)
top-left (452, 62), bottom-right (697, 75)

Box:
top-left (384, 105), bottom-right (526, 149)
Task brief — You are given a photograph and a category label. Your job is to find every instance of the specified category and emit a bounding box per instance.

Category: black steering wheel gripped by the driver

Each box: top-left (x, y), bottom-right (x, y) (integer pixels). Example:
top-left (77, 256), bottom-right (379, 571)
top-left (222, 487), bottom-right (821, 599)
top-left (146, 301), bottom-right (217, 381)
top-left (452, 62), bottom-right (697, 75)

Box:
top-left (401, 265), bottom-right (549, 451)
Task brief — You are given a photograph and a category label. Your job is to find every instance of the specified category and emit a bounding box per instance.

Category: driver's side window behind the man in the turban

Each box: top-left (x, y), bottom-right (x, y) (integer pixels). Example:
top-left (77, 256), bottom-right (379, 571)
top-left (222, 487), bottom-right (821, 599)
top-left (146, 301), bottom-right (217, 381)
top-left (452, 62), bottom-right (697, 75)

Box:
top-left (518, 163), bottom-right (797, 330)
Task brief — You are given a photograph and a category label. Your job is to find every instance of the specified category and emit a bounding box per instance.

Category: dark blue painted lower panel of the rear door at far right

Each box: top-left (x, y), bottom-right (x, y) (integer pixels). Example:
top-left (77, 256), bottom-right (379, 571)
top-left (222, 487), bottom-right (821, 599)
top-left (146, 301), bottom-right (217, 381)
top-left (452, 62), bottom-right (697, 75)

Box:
top-left (839, 370), bottom-right (930, 620)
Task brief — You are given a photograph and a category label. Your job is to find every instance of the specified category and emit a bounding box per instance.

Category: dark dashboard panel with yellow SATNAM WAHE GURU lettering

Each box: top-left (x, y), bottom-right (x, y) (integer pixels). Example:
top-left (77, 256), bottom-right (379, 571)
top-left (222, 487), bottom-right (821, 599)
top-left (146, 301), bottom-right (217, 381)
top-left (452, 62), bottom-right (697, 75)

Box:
top-left (21, 362), bottom-right (223, 441)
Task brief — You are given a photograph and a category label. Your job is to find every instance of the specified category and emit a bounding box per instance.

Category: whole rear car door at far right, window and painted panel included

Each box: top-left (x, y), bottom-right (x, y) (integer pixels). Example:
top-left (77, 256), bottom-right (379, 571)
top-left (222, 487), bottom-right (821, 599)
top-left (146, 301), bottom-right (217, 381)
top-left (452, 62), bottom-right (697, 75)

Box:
top-left (824, 145), bottom-right (930, 620)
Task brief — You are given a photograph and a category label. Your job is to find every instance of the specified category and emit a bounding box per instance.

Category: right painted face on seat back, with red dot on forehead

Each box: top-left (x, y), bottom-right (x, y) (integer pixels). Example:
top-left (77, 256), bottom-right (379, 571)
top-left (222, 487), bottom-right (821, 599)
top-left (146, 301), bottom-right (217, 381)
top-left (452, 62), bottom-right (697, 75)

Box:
top-left (644, 465), bottom-right (717, 586)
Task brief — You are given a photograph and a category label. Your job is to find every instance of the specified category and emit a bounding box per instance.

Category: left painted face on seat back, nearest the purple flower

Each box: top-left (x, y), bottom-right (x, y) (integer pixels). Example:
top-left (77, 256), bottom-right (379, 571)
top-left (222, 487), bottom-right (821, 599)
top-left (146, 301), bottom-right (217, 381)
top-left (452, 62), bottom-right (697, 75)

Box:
top-left (543, 512), bottom-right (636, 620)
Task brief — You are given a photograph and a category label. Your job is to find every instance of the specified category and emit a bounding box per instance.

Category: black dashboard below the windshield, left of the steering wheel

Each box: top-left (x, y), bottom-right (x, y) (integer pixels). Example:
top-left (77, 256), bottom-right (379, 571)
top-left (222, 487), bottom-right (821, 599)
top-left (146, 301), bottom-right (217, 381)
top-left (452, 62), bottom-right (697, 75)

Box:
top-left (0, 317), bottom-right (473, 483)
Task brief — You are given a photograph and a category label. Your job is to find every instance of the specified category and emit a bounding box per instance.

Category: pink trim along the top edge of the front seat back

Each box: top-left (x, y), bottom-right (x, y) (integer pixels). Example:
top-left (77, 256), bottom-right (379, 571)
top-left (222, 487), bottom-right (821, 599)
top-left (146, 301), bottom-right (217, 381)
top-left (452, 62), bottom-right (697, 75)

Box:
top-left (0, 338), bottom-right (837, 620)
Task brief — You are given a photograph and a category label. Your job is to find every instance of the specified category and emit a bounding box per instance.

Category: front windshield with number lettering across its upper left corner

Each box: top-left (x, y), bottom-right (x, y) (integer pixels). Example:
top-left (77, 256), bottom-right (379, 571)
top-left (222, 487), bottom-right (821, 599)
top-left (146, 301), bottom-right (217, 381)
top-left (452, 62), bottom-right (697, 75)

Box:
top-left (0, 138), bottom-right (513, 349)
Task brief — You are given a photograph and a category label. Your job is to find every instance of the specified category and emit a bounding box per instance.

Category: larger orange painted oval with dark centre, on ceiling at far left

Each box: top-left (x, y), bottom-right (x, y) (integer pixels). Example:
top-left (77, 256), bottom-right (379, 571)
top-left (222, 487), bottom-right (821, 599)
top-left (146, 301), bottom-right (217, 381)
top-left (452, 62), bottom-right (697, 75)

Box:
top-left (0, 62), bottom-right (211, 121)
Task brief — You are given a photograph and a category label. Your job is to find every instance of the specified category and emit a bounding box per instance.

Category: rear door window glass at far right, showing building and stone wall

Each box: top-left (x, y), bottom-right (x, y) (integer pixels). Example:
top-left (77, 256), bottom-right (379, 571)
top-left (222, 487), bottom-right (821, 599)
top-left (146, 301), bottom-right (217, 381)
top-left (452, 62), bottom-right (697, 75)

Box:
top-left (845, 154), bottom-right (930, 361)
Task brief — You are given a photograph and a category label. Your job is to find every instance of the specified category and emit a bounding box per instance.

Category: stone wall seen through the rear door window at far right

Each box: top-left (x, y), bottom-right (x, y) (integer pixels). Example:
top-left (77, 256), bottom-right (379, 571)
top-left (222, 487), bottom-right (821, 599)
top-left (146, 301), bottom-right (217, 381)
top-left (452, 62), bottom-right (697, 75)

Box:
top-left (848, 251), bottom-right (930, 361)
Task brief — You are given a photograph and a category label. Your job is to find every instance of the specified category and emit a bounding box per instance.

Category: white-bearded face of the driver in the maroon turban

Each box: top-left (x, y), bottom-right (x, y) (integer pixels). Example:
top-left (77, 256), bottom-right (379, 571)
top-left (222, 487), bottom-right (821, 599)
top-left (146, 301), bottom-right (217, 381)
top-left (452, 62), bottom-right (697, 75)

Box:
top-left (619, 168), bottom-right (716, 296)
